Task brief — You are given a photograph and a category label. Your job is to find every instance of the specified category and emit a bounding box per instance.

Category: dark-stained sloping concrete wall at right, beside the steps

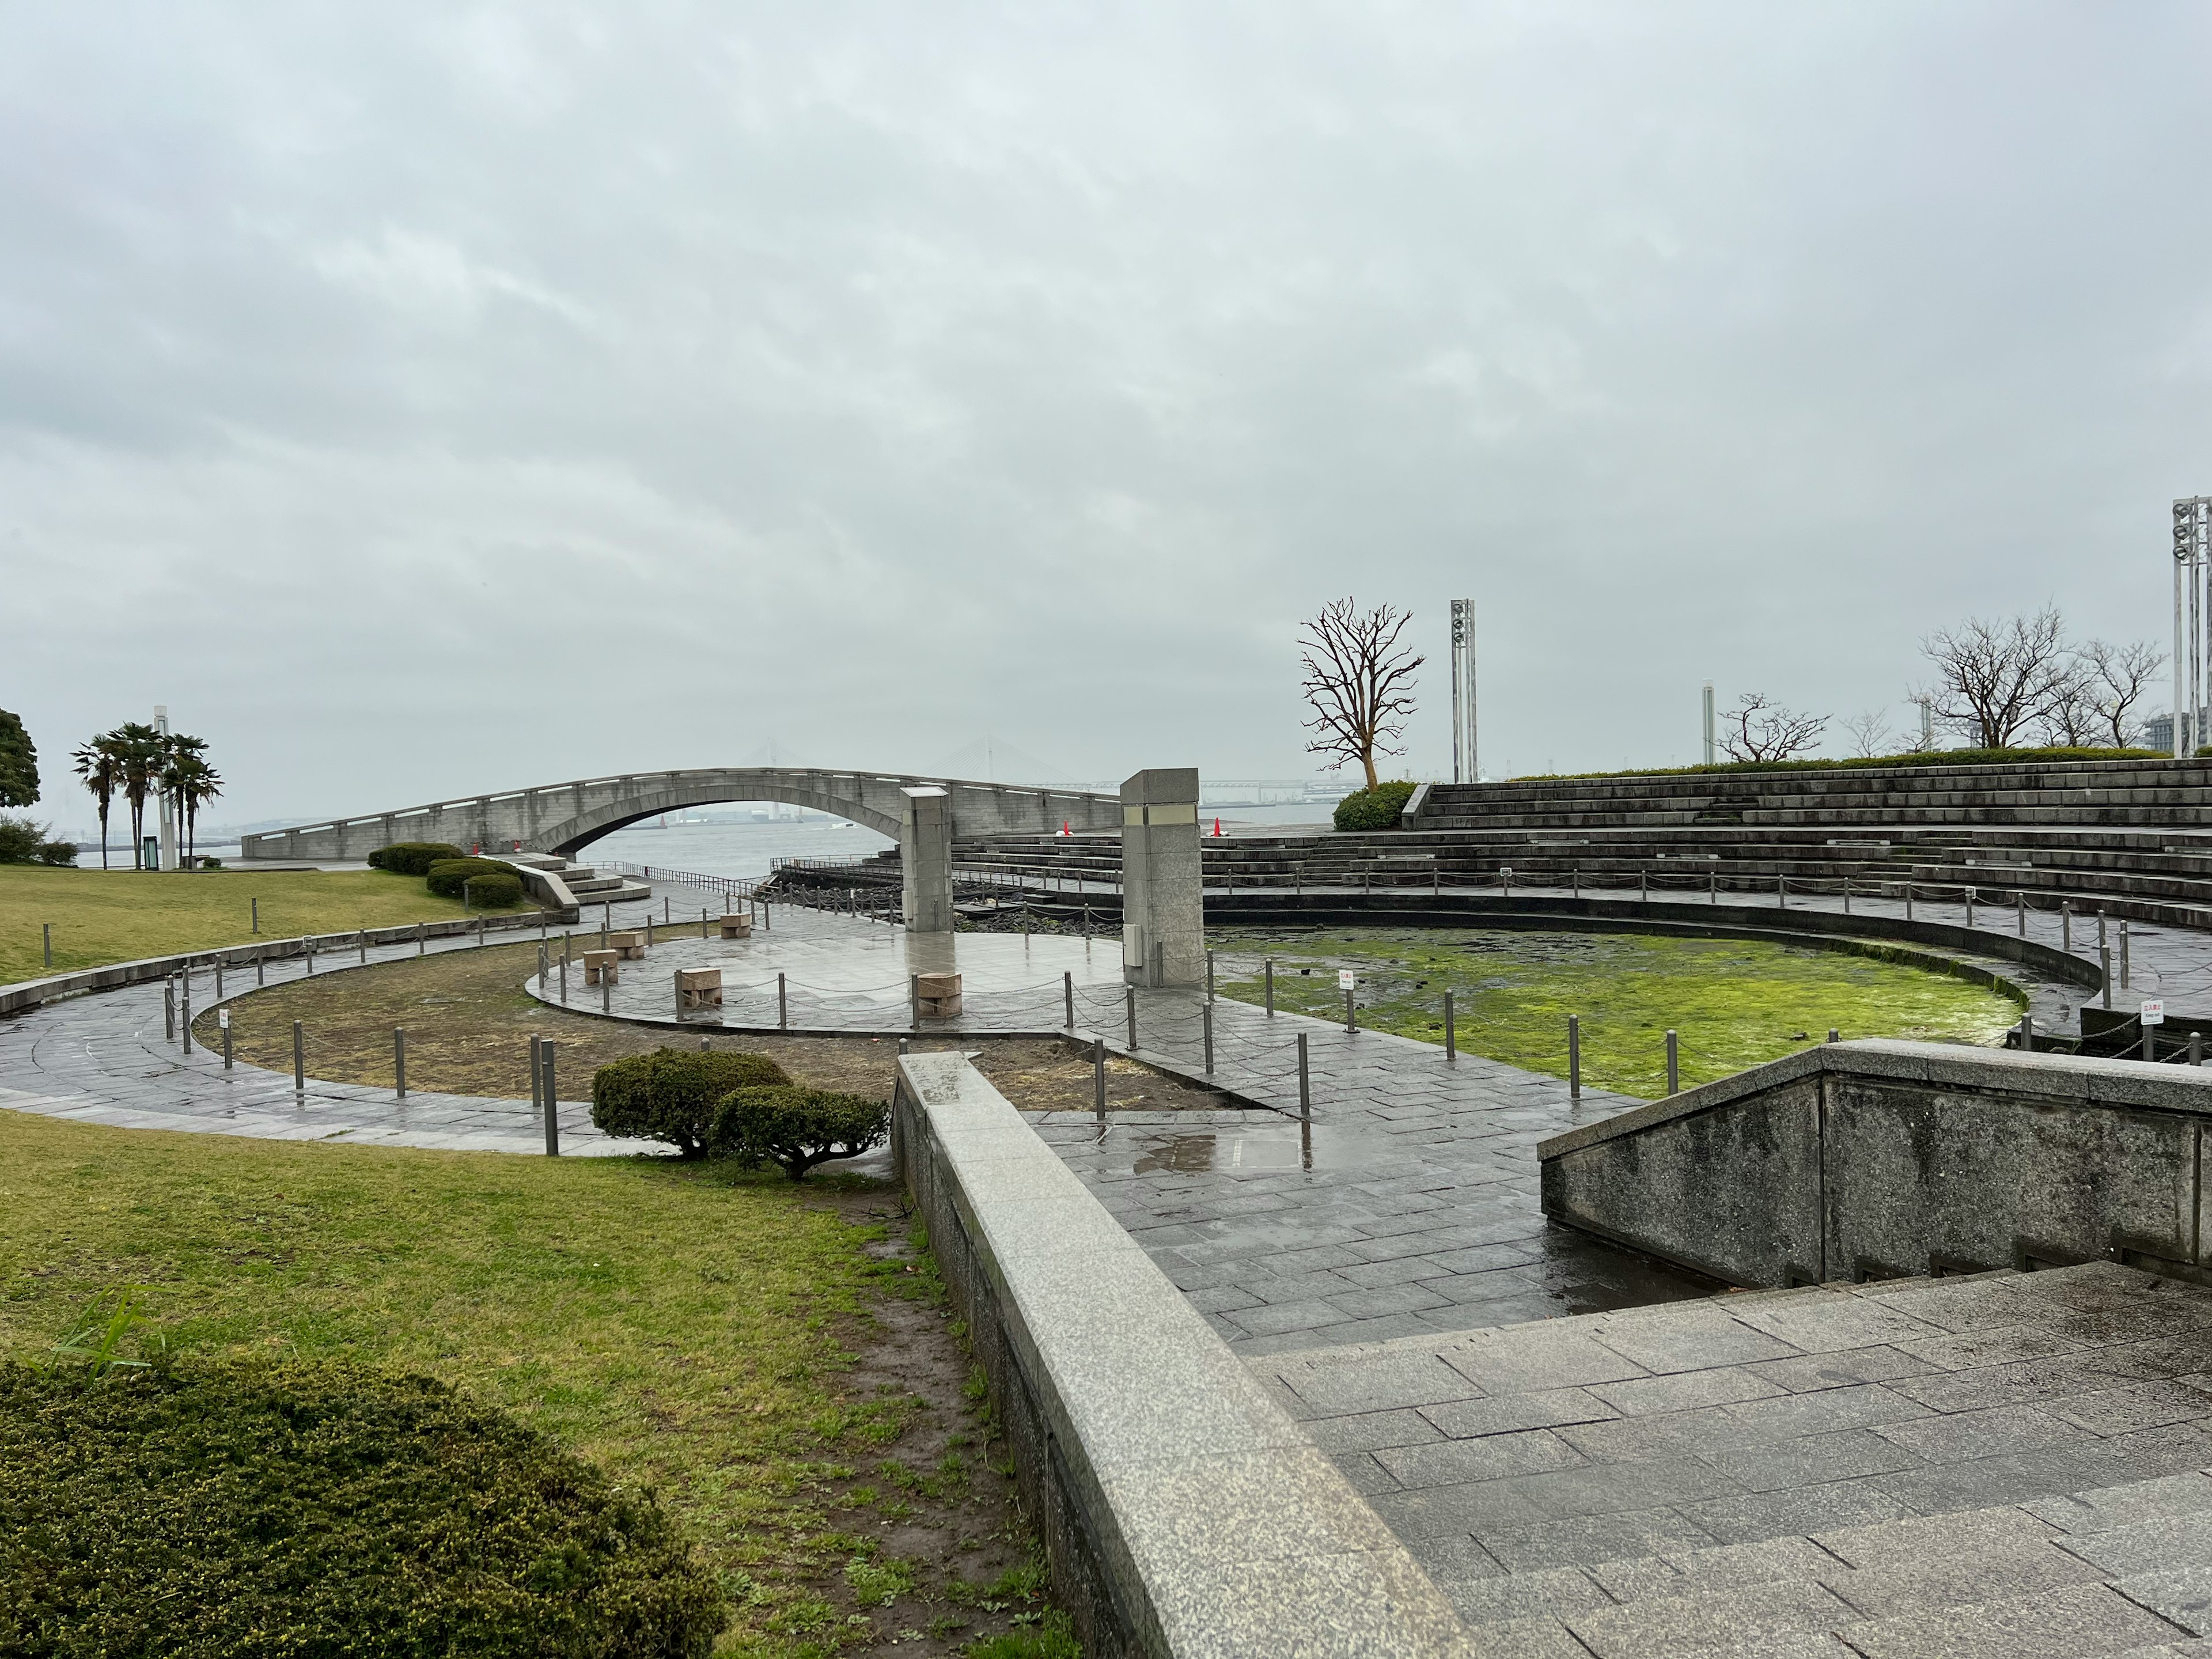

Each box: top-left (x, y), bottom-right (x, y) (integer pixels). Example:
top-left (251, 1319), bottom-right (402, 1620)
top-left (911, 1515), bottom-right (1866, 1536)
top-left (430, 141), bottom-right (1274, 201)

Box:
top-left (1537, 1042), bottom-right (2212, 1287)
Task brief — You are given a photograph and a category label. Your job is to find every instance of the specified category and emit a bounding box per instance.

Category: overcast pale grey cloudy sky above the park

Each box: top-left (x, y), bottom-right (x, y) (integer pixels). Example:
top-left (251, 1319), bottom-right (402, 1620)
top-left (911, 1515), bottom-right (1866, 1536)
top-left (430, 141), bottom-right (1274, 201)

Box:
top-left (0, 0), bottom-right (2212, 823)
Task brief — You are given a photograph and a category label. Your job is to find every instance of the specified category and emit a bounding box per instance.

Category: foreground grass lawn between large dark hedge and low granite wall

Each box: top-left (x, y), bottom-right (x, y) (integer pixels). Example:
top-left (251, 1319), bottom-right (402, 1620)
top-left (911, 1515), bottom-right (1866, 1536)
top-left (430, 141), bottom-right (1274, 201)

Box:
top-left (0, 1113), bottom-right (1071, 1659)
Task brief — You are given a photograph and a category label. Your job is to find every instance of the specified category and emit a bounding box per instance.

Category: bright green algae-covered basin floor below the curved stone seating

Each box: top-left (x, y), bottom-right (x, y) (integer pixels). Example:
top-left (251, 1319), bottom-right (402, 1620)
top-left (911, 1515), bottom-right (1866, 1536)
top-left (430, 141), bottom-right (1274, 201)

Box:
top-left (1210, 927), bottom-right (2020, 1099)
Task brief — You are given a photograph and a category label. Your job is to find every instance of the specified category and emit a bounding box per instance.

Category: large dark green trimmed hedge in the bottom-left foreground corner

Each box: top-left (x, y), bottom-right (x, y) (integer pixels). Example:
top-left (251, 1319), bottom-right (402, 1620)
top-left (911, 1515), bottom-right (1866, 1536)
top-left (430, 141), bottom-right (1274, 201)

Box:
top-left (0, 1362), bottom-right (726, 1659)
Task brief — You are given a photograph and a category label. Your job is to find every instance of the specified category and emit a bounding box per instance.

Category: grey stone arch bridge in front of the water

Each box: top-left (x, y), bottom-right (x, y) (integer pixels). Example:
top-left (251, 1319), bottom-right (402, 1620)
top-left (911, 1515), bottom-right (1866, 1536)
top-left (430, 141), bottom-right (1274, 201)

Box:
top-left (239, 766), bottom-right (1122, 861)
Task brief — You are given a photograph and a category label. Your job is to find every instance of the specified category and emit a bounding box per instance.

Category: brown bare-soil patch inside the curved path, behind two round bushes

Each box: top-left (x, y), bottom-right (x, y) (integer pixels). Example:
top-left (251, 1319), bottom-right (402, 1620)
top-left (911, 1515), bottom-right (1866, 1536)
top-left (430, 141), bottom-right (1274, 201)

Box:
top-left (192, 945), bottom-right (1225, 1113)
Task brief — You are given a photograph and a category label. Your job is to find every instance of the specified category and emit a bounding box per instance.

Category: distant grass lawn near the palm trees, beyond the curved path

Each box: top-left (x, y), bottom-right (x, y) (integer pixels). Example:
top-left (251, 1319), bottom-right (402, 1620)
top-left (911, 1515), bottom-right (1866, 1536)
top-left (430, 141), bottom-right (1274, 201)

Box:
top-left (0, 865), bottom-right (535, 984)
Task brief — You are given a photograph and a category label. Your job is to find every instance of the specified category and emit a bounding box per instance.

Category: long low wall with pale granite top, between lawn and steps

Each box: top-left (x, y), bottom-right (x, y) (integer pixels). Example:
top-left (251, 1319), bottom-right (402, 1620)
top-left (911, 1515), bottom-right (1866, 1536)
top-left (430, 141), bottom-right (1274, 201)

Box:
top-left (892, 1055), bottom-right (1473, 1659)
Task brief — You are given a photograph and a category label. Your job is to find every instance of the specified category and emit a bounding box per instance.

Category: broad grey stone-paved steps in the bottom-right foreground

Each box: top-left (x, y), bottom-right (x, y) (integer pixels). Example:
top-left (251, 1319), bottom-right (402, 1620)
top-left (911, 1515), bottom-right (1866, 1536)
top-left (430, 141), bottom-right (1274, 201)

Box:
top-left (1252, 1263), bottom-right (2212, 1659)
